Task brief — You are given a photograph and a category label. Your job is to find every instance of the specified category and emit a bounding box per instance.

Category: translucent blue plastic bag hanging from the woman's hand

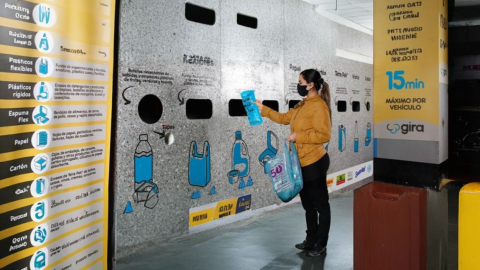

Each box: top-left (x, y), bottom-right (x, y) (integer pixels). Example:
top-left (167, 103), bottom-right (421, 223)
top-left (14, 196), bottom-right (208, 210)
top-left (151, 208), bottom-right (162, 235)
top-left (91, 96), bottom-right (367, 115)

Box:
top-left (265, 142), bottom-right (303, 202)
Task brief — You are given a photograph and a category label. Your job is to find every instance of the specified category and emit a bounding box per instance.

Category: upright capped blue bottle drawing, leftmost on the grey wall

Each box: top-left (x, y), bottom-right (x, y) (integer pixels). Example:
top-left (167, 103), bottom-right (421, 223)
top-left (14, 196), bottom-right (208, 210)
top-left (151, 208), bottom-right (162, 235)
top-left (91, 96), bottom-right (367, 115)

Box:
top-left (135, 134), bottom-right (153, 191)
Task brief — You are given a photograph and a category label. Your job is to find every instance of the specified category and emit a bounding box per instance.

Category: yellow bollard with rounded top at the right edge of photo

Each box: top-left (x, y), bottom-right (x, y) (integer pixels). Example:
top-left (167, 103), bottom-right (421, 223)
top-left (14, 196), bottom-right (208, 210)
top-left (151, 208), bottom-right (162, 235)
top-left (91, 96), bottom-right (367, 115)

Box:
top-left (458, 183), bottom-right (480, 270)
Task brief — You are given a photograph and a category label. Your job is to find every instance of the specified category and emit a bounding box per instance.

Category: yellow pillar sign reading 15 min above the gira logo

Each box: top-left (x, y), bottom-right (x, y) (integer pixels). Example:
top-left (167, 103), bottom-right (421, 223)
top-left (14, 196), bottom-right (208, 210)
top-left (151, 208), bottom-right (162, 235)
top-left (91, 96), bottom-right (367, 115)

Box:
top-left (374, 0), bottom-right (448, 141)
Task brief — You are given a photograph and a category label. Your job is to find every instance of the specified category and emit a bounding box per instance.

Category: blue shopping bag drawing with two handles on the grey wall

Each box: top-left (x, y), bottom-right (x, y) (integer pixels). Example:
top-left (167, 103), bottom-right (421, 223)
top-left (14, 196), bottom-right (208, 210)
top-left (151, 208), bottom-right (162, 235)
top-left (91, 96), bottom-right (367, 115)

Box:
top-left (188, 141), bottom-right (210, 187)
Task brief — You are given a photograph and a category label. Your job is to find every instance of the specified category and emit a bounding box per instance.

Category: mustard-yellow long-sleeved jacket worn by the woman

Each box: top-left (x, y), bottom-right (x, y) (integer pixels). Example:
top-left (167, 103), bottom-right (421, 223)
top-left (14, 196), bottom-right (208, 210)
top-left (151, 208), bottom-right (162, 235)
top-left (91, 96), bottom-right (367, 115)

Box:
top-left (261, 95), bottom-right (332, 167)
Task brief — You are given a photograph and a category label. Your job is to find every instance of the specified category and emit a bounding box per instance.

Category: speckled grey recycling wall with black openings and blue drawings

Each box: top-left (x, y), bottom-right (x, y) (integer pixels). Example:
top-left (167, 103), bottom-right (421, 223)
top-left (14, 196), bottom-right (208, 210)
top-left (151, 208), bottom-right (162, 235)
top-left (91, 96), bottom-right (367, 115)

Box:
top-left (113, 0), bottom-right (373, 258)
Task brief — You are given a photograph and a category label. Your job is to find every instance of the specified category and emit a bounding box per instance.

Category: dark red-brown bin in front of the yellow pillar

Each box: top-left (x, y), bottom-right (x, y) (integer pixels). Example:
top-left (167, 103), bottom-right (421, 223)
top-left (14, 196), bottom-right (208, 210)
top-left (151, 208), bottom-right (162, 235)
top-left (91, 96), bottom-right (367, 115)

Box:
top-left (354, 182), bottom-right (427, 270)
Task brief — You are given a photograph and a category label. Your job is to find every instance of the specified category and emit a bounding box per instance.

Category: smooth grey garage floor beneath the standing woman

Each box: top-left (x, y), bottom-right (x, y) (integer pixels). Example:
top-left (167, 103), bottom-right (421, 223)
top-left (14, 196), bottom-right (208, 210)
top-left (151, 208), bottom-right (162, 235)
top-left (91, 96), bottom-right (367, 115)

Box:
top-left (116, 191), bottom-right (458, 270)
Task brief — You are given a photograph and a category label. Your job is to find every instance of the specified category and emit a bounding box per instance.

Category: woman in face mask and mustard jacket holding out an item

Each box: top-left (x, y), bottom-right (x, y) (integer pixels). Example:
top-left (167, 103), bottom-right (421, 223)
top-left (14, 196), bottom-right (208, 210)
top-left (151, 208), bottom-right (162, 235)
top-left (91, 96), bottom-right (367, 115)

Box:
top-left (255, 69), bottom-right (331, 257)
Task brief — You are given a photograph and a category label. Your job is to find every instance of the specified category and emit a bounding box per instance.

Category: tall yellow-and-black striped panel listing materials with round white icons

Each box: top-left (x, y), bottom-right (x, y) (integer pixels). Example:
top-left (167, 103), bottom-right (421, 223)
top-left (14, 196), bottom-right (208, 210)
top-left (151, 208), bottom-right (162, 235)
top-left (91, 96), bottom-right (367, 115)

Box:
top-left (0, 0), bottom-right (115, 270)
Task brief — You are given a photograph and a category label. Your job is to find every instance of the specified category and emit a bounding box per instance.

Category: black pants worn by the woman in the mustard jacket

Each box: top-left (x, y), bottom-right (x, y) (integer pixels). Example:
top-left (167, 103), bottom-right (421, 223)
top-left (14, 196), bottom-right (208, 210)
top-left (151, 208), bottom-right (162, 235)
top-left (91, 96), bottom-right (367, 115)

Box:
top-left (300, 153), bottom-right (331, 247)
